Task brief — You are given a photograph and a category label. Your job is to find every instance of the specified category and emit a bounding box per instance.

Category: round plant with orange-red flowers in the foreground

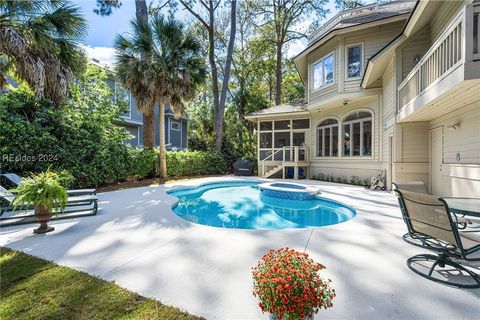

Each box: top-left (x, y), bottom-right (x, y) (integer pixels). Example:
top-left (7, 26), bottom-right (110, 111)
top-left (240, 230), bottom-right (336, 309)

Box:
top-left (252, 247), bottom-right (335, 320)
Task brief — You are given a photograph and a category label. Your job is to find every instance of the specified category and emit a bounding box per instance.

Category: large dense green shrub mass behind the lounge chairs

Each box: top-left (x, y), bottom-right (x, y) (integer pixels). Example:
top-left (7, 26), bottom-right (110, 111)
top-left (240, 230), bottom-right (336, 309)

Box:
top-left (0, 66), bottom-right (130, 187)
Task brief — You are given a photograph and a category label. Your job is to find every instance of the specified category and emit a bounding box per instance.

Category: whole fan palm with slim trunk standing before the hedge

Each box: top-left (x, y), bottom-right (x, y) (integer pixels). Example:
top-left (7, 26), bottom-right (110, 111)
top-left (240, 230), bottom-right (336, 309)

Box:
top-left (115, 14), bottom-right (206, 177)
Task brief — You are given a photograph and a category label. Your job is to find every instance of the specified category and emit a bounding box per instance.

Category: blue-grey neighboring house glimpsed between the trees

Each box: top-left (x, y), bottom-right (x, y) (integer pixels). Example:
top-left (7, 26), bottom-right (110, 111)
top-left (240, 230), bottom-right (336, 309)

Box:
top-left (93, 60), bottom-right (189, 150)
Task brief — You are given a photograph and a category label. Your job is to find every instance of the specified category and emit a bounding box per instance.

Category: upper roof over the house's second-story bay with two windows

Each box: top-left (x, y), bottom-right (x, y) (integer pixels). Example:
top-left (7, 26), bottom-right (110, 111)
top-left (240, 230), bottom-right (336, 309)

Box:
top-left (308, 0), bottom-right (416, 47)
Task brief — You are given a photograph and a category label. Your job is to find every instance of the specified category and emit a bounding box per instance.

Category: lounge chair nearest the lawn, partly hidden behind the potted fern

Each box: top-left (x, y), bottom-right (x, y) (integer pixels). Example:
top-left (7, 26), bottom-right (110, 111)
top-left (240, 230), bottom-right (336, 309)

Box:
top-left (0, 186), bottom-right (98, 227)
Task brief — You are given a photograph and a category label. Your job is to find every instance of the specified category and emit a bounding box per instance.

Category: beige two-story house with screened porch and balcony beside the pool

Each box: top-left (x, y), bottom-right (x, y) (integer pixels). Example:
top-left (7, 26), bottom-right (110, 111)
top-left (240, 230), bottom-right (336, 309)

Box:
top-left (246, 0), bottom-right (480, 197)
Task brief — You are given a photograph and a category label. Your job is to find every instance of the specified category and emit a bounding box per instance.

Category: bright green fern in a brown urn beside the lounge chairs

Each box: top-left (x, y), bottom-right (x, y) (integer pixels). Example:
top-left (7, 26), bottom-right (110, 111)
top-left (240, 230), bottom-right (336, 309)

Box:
top-left (13, 170), bottom-right (71, 233)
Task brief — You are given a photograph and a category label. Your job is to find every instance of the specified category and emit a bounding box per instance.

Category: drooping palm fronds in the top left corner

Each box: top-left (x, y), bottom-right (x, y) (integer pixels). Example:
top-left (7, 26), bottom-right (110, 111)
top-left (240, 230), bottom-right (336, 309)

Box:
top-left (0, 0), bottom-right (87, 105)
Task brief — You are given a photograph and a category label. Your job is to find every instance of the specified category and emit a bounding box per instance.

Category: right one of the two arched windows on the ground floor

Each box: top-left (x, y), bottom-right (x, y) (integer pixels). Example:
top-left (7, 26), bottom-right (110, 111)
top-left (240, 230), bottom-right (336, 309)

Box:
top-left (342, 111), bottom-right (373, 157)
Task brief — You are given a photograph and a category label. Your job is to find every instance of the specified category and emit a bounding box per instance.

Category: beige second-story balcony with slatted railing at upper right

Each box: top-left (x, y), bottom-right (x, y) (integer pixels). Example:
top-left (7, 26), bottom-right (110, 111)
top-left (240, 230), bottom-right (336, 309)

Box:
top-left (397, 3), bottom-right (480, 121)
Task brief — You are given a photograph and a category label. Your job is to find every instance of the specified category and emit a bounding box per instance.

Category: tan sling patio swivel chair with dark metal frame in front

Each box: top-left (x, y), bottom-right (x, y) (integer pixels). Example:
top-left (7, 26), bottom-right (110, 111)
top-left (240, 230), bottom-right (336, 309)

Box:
top-left (395, 189), bottom-right (480, 288)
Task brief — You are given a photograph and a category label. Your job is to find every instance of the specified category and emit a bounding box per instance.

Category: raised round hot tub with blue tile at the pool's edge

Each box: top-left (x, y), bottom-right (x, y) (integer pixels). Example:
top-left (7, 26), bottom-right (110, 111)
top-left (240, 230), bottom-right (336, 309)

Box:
top-left (258, 182), bottom-right (320, 200)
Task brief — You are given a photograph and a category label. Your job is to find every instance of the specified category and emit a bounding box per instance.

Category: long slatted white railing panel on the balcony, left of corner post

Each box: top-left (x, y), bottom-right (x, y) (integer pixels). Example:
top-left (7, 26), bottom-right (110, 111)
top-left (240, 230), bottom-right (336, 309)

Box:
top-left (397, 15), bottom-right (464, 111)
